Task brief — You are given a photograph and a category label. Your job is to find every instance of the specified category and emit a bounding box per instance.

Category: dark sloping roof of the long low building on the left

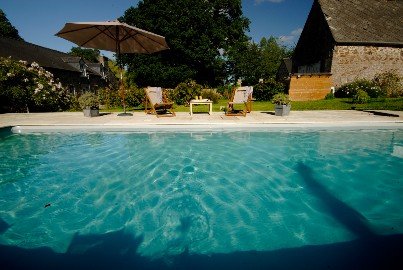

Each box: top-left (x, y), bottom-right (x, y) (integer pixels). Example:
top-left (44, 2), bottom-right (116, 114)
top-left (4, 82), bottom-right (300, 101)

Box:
top-left (0, 37), bottom-right (81, 73)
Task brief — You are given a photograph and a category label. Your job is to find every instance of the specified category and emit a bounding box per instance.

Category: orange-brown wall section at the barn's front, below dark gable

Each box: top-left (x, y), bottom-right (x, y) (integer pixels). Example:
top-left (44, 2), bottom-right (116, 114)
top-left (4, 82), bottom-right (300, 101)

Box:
top-left (289, 74), bottom-right (332, 101)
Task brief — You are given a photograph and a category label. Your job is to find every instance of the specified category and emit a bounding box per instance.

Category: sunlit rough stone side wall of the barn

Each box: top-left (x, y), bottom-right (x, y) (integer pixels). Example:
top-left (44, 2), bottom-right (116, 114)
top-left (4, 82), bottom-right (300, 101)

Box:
top-left (331, 46), bottom-right (403, 87)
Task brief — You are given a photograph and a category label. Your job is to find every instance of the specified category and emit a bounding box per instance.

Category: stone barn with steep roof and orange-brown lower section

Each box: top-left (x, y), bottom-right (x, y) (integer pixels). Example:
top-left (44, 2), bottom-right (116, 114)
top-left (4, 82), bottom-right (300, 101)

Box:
top-left (289, 0), bottom-right (403, 100)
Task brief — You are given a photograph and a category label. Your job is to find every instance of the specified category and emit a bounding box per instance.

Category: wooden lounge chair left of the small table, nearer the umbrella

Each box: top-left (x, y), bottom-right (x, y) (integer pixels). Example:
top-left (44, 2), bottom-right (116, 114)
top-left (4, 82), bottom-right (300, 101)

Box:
top-left (144, 87), bottom-right (175, 117)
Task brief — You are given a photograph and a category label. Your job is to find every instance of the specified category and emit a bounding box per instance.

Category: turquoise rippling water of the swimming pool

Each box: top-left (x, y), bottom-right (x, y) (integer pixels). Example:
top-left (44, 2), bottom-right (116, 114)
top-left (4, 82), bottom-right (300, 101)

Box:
top-left (0, 129), bottom-right (403, 268)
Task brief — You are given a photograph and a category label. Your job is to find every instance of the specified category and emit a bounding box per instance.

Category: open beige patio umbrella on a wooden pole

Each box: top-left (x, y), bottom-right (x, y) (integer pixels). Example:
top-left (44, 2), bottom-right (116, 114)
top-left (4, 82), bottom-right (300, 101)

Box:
top-left (56, 20), bottom-right (169, 113)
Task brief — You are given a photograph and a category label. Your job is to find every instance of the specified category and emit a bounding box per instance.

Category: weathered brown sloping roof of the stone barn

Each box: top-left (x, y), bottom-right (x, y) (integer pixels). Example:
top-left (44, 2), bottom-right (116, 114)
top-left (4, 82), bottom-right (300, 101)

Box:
top-left (317, 0), bottom-right (403, 45)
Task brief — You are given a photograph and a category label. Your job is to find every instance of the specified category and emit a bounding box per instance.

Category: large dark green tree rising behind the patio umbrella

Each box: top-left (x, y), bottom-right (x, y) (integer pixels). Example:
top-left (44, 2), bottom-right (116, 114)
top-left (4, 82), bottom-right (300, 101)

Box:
top-left (120, 0), bottom-right (249, 87)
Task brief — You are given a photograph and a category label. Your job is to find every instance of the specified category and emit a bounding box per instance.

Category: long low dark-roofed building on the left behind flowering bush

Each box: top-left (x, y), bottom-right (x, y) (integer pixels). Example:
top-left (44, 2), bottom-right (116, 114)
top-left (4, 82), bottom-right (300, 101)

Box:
top-left (0, 37), bottom-right (116, 94)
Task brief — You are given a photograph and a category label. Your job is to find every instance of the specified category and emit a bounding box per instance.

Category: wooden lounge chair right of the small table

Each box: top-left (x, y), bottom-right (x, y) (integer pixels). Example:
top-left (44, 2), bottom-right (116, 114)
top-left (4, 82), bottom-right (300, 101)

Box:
top-left (225, 86), bottom-right (253, 116)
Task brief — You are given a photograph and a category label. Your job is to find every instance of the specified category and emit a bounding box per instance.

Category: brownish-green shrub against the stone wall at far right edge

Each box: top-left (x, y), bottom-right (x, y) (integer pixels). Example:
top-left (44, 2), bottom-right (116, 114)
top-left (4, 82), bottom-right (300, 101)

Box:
top-left (374, 71), bottom-right (403, 97)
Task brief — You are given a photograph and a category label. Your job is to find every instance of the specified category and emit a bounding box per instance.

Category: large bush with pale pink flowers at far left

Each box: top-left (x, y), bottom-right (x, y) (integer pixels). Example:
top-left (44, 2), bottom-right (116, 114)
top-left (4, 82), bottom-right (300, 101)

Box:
top-left (0, 58), bottom-right (71, 112)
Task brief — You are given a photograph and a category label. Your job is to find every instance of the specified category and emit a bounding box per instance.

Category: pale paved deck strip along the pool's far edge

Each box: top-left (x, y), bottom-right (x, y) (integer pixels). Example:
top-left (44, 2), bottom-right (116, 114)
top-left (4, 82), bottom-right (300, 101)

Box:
top-left (0, 110), bottom-right (403, 129)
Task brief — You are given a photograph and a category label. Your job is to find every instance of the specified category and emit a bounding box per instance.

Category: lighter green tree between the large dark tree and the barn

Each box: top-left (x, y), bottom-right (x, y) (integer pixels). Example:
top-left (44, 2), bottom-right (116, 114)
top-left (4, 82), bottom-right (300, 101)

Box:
top-left (227, 36), bottom-right (293, 85)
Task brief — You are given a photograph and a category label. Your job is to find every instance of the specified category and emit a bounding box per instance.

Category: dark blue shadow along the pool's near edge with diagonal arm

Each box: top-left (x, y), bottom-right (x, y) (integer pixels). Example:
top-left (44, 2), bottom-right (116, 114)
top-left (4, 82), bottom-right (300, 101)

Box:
top-left (0, 163), bottom-right (403, 270)
